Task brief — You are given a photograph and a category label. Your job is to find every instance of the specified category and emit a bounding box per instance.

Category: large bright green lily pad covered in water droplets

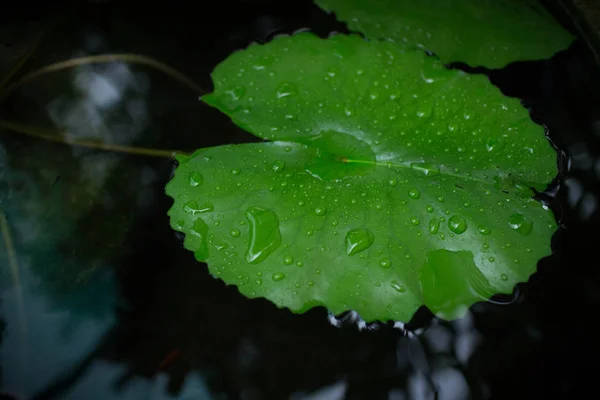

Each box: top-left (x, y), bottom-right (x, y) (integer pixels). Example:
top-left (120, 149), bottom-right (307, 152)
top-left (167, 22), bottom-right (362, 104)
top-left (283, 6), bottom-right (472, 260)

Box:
top-left (166, 33), bottom-right (556, 321)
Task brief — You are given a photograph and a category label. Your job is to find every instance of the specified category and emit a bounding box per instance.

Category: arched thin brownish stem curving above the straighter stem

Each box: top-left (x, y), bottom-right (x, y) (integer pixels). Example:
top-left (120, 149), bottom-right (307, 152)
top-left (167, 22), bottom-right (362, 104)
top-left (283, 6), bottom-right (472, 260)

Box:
top-left (0, 53), bottom-right (206, 101)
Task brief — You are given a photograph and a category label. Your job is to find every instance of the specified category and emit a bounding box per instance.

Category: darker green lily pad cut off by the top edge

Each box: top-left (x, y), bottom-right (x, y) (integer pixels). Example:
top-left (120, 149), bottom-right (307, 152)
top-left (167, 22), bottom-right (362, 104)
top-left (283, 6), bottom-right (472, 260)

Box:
top-left (316, 0), bottom-right (574, 68)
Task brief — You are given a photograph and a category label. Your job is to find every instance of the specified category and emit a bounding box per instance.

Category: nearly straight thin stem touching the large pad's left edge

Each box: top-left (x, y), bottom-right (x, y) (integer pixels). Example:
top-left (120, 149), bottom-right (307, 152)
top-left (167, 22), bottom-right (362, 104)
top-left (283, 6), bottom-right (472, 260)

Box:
top-left (0, 120), bottom-right (188, 158)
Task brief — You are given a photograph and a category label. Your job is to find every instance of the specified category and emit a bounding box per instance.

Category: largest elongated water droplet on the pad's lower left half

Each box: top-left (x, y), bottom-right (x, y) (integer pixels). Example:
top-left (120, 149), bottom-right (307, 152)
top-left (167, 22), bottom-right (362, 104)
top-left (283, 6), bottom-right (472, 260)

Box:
top-left (246, 207), bottom-right (281, 264)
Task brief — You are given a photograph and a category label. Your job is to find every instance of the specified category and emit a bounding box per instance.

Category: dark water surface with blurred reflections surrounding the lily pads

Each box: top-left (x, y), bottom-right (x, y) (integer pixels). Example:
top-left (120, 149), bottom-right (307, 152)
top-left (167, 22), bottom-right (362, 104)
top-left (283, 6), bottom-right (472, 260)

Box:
top-left (0, 1), bottom-right (600, 400)
